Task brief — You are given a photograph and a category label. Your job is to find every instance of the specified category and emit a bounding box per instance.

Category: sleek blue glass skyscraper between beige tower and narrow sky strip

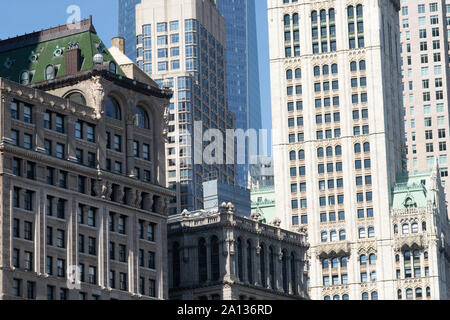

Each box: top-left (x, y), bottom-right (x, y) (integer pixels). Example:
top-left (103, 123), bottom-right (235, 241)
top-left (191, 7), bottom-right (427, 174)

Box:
top-left (216, 0), bottom-right (262, 187)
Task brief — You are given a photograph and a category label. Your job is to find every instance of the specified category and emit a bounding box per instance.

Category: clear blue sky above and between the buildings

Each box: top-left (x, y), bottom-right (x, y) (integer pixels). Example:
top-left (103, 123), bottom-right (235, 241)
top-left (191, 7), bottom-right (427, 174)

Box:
top-left (0, 0), bottom-right (272, 154)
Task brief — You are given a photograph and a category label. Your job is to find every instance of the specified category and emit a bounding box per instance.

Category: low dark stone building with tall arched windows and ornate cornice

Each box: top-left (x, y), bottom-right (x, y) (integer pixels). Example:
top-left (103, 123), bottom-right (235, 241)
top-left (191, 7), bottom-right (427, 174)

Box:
top-left (168, 203), bottom-right (308, 300)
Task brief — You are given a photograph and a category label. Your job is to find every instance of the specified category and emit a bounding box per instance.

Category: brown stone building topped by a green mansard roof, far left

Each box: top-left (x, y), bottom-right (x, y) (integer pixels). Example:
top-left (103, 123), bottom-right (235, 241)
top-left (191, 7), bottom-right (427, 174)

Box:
top-left (0, 19), bottom-right (174, 300)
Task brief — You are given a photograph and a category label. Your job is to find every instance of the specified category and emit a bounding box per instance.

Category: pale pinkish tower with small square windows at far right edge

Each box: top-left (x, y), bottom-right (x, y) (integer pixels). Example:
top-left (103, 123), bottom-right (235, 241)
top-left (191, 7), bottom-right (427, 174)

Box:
top-left (400, 0), bottom-right (450, 216)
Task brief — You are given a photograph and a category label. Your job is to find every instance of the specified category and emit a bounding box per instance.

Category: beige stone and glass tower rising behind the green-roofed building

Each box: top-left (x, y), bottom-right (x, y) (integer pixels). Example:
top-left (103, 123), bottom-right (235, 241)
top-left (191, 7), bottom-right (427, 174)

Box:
top-left (136, 0), bottom-right (236, 214)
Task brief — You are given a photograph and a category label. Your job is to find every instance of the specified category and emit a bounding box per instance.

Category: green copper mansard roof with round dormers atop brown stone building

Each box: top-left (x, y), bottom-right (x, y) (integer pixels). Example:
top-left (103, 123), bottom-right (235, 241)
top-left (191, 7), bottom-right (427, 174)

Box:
top-left (0, 21), bottom-right (125, 84)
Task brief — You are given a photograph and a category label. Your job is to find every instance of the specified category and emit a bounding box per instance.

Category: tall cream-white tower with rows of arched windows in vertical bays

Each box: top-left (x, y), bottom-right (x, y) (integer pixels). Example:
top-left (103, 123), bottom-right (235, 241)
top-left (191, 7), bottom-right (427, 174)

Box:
top-left (268, 0), bottom-right (406, 300)
